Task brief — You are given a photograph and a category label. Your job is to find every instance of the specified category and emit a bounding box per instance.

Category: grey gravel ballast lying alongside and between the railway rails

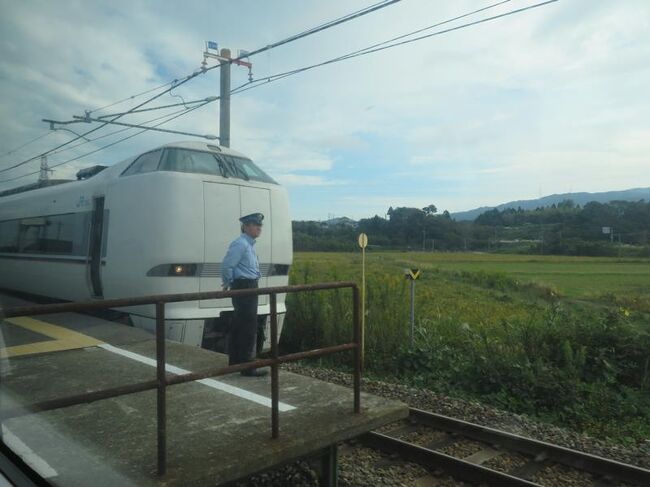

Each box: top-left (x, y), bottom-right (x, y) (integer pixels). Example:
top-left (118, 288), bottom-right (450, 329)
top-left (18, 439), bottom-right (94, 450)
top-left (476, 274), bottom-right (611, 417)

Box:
top-left (232, 364), bottom-right (650, 487)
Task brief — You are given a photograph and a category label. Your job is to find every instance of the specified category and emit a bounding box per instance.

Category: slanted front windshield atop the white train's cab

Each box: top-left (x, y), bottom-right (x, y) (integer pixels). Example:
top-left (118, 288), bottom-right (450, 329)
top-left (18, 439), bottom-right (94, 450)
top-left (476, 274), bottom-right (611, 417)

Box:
top-left (158, 149), bottom-right (277, 184)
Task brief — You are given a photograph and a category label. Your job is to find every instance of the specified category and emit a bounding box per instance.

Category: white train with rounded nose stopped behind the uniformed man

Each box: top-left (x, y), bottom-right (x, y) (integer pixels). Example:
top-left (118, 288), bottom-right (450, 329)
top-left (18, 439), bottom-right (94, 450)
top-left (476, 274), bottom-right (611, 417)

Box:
top-left (0, 142), bottom-right (293, 348)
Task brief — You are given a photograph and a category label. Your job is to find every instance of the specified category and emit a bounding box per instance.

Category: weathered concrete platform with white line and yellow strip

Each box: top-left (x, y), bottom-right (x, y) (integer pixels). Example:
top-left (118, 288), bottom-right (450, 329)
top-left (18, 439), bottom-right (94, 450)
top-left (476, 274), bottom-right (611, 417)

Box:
top-left (0, 296), bottom-right (408, 486)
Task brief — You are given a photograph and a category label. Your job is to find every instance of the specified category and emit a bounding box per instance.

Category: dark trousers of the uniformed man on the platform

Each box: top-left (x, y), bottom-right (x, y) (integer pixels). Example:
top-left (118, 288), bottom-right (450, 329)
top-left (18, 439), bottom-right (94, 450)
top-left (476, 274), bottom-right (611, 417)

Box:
top-left (229, 279), bottom-right (257, 365)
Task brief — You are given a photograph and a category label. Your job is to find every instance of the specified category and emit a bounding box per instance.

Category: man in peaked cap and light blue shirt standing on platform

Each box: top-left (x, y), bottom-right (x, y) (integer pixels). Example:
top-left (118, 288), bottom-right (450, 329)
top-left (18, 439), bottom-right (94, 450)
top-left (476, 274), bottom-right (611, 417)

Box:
top-left (221, 213), bottom-right (268, 377)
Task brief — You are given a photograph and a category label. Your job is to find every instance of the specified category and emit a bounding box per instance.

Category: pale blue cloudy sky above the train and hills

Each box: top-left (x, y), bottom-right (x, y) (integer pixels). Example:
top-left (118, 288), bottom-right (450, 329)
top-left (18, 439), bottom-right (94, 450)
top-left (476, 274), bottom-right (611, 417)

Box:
top-left (0, 0), bottom-right (650, 220)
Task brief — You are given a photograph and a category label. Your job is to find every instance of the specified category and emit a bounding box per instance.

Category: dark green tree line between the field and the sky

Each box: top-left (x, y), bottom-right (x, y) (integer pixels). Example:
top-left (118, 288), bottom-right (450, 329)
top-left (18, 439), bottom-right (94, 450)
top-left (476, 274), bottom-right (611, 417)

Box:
top-left (293, 200), bottom-right (650, 256)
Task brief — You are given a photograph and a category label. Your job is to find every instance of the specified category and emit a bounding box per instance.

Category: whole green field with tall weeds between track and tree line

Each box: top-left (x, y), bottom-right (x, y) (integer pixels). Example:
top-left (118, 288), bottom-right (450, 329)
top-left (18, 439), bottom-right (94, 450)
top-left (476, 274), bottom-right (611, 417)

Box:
top-left (282, 252), bottom-right (650, 443)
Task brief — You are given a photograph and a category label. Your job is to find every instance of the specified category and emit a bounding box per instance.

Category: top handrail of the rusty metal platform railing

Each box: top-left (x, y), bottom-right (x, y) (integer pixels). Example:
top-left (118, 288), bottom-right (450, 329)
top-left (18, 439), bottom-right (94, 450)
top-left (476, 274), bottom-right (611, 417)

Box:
top-left (0, 281), bottom-right (357, 318)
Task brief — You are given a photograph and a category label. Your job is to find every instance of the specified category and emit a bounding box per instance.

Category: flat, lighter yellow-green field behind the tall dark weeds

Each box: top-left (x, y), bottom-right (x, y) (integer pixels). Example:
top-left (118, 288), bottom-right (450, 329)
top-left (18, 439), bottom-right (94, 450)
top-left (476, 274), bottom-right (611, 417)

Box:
top-left (291, 252), bottom-right (650, 322)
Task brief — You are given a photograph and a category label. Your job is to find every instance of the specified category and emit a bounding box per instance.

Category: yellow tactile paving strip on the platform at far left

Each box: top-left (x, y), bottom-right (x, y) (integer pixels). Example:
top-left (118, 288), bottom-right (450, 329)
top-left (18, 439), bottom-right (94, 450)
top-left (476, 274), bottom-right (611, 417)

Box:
top-left (0, 316), bottom-right (104, 359)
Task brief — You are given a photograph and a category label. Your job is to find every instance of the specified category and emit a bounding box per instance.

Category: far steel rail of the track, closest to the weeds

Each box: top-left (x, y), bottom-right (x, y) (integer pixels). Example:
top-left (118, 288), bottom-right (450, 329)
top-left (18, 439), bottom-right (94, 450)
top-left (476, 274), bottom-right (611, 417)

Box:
top-left (409, 408), bottom-right (650, 485)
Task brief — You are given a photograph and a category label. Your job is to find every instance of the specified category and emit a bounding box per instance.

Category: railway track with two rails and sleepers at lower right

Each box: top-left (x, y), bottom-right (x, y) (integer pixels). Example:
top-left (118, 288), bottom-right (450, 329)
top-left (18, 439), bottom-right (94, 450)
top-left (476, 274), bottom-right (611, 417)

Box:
top-left (361, 408), bottom-right (650, 487)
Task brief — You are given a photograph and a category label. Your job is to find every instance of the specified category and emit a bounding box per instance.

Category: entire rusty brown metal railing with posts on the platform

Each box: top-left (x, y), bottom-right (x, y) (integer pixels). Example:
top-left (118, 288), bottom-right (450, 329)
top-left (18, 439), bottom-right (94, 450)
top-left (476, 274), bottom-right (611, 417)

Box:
top-left (1, 282), bottom-right (361, 475)
